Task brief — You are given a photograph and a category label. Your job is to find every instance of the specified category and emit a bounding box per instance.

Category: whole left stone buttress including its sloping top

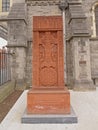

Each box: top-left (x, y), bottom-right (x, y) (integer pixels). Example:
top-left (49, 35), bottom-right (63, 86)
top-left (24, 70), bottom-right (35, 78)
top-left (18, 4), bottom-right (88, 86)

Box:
top-left (8, 3), bottom-right (27, 89)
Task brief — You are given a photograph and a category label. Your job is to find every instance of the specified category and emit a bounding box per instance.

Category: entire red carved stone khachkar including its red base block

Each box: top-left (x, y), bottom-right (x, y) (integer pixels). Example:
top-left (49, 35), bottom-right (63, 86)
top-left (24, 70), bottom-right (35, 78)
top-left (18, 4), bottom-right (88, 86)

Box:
top-left (27, 16), bottom-right (70, 114)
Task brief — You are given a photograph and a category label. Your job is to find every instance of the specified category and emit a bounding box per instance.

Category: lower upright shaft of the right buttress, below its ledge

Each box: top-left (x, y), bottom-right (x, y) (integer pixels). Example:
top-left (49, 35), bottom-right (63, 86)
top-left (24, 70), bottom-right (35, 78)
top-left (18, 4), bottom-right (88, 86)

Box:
top-left (71, 37), bottom-right (94, 90)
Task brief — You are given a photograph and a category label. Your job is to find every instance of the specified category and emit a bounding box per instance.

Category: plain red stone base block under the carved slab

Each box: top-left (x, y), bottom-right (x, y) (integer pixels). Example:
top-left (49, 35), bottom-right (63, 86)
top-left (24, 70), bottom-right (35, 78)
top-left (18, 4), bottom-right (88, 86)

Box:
top-left (27, 88), bottom-right (70, 114)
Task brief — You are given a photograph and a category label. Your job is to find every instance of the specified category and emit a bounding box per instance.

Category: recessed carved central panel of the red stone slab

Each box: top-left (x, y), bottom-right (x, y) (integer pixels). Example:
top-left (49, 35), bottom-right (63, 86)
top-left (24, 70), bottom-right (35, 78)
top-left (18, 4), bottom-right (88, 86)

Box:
top-left (39, 32), bottom-right (57, 87)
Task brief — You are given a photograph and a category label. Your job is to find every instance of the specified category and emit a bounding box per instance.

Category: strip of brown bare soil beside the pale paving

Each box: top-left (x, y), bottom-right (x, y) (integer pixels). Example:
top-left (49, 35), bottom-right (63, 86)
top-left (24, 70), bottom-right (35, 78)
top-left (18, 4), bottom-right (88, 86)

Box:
top-left (0, 90), bottom-right (23, 122)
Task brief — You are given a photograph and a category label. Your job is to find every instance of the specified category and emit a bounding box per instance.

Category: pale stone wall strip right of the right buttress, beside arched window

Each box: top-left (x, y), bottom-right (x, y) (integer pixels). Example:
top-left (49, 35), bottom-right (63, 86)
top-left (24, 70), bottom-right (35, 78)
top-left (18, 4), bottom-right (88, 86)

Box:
top-left (83, 0), bottom-right (98, 86)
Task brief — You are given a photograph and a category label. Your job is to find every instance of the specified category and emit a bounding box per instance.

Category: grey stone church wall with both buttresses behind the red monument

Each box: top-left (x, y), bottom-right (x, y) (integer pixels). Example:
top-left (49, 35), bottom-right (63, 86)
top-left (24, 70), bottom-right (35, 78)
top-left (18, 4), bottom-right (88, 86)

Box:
top-left (5, 0), bottom-right (98, 89)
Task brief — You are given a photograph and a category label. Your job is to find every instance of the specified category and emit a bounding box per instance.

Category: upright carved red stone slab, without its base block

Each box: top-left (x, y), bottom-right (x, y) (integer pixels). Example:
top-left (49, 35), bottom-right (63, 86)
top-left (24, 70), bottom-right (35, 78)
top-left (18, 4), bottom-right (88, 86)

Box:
top-left (33, 16), bottom-right (64, 88)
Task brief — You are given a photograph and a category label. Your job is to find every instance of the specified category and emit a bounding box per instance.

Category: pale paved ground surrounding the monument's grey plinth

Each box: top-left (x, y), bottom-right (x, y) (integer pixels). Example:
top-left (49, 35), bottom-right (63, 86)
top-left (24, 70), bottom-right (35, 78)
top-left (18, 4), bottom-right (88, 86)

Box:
top-left (0, 87), bottom-right (98, 130)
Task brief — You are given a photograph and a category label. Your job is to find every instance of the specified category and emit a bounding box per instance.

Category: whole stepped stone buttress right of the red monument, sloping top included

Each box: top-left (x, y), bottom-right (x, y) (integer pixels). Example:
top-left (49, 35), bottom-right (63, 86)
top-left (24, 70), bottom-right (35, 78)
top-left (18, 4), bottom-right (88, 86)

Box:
top-left (67, 0), bottom-right (95, 90)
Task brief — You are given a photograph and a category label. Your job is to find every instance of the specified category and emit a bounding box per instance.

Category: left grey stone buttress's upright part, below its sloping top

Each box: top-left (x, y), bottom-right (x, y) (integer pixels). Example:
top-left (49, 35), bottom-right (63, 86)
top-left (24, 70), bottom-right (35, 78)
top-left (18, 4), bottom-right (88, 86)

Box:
top-left (7, 20), bottom-right (27, 89)
